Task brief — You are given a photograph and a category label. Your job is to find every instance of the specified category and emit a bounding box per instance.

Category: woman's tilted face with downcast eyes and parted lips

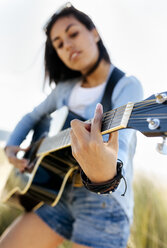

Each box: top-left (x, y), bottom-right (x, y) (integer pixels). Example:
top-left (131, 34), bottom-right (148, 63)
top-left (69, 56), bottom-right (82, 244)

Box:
top-left (50, 16), bottom-right (99, 74)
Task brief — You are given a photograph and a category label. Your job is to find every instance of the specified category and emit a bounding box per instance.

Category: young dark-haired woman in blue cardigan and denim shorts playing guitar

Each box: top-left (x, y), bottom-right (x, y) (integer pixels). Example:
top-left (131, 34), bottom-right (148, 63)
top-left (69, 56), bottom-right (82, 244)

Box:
top-left (0, 4), bottom-right (142, 248)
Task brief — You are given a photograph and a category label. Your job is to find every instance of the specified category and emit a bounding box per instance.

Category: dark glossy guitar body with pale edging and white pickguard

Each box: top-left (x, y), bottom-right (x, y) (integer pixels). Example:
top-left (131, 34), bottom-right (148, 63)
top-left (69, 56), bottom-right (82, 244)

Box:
top-left (1, 107), bottom-right (83, 211)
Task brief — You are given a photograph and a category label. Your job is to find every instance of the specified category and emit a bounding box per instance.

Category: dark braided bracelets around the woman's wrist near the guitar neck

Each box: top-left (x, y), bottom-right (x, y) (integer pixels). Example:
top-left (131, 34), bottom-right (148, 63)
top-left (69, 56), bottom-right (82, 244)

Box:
top-left (81, 160), bottom-right (127, 196)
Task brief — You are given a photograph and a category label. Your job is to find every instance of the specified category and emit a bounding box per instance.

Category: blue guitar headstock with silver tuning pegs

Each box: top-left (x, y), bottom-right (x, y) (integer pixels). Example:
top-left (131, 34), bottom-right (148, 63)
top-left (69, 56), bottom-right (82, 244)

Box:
top-left (127, 92), bottom-right (167, 137)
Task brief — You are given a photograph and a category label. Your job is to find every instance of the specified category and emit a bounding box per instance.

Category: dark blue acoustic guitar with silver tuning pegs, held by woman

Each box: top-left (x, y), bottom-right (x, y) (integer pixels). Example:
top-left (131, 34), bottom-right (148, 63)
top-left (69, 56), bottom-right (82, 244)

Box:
top-left (0, 92), bottom-right (167, 211)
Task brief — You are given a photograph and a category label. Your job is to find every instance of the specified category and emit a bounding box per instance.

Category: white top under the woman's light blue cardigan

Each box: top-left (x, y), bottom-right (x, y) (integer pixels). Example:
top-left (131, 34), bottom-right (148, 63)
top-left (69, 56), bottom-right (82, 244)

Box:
top-left (68, 82), bottom-right (106, 116)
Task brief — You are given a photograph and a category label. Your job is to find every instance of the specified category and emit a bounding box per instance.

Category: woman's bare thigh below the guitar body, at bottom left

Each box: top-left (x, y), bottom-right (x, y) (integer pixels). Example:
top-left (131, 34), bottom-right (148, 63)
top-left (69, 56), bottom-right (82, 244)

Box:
top-left (0, 213), bottom-right (64, 248)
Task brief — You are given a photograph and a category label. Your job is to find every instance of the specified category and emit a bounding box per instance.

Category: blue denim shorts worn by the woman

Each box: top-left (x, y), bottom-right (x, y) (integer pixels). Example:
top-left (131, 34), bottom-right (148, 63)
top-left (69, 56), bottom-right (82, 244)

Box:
top-left (35, 186), bottom-right (130, 248)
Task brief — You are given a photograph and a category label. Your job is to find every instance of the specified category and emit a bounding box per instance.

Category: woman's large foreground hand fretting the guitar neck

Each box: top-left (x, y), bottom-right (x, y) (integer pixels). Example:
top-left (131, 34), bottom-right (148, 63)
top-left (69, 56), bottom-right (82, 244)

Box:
top-left (70, 104), bottom-right (118, 182)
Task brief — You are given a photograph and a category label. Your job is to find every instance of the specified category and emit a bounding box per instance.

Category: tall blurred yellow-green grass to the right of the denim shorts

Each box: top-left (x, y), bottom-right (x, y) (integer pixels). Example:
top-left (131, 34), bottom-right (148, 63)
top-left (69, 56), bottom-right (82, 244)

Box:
top-left (130, 172), bottom-right (167, 248)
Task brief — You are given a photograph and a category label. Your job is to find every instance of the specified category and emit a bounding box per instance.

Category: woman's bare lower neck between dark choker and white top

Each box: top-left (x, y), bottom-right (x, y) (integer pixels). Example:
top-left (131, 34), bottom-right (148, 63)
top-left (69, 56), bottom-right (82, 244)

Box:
top-left (82, 60), bottom-right (111, 88)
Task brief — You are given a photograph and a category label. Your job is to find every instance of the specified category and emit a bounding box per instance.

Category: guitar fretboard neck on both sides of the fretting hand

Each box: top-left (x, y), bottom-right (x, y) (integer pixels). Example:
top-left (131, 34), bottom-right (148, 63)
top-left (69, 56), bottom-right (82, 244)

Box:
top-left (37, 103), bottom-right (134, 156)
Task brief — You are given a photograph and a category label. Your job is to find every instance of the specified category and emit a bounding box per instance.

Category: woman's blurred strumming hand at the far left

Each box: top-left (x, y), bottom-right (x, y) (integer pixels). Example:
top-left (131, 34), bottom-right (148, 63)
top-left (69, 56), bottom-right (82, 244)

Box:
top-left (4, 146), bottom-right (28, 172)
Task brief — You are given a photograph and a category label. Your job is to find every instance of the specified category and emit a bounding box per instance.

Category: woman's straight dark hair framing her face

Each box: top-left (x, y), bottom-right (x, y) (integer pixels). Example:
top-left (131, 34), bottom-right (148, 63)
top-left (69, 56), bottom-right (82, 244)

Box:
top-left (44, 3), bottom-right (110, 84)
